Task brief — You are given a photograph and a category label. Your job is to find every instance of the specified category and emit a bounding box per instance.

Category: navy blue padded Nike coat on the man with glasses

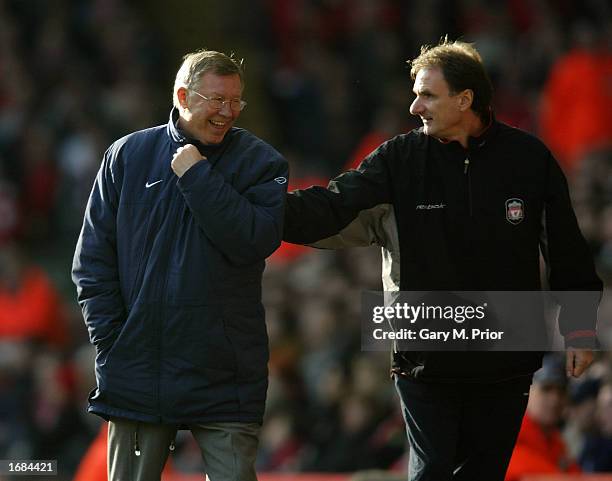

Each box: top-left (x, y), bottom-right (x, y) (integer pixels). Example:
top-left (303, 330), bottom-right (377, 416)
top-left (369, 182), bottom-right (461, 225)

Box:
top-left (72, 110), bottom-right (288, 424)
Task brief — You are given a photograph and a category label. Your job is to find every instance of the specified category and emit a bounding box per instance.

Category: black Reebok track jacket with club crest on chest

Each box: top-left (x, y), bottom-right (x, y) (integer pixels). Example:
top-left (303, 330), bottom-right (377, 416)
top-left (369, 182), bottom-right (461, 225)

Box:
top-left (284, 120), bottom-right (602, 382)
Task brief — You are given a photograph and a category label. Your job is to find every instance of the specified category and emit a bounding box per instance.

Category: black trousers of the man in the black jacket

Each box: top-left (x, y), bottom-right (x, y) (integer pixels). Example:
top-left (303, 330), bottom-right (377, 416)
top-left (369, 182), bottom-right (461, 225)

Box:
top-left (395, 375), bottom-right (531, 481)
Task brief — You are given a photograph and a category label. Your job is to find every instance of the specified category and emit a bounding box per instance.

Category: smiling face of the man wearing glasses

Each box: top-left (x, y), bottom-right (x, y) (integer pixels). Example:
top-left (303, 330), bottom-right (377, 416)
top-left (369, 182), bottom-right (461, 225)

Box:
top-left (181, 72), bottom-right (242, 144)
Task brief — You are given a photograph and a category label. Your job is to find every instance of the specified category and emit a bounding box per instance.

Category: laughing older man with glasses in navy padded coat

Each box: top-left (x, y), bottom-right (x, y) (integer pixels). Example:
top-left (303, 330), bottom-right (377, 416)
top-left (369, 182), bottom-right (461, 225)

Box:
top-left (72, 50), bottom-right (287, 481)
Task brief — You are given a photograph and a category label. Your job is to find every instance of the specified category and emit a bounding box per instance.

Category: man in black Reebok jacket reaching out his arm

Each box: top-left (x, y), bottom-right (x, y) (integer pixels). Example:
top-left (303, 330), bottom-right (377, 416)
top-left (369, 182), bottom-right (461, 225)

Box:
top-left (284, 40), bottom-right (602, 481)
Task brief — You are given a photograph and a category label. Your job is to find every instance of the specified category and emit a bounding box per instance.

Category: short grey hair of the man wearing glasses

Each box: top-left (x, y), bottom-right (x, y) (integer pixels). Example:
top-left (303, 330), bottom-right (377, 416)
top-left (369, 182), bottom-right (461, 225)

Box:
top-left (172, 49), bottom-right (244, 108)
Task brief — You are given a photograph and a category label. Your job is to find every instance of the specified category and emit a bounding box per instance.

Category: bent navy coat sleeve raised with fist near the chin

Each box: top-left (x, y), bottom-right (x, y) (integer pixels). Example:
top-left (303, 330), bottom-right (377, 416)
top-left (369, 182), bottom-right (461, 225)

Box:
top-left (177, 151), bottom-right (288, 265)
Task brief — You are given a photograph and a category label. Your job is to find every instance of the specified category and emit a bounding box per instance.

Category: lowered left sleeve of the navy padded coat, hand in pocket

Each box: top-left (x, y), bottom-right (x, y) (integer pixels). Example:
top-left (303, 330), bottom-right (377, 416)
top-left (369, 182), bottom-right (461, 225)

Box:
top-left (72, 149), bottom-right (126, 347)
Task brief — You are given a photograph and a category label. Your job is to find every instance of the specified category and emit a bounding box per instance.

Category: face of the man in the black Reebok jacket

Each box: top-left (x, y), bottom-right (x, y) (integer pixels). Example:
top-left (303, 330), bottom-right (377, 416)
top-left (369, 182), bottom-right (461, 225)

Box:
top-left (410, 68), bottom-right (464, 139)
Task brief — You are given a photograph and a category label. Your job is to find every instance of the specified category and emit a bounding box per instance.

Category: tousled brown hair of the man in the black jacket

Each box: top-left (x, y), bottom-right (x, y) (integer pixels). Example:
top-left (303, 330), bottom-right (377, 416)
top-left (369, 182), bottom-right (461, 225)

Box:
top-left (408, 37), bottom-right (493, 124)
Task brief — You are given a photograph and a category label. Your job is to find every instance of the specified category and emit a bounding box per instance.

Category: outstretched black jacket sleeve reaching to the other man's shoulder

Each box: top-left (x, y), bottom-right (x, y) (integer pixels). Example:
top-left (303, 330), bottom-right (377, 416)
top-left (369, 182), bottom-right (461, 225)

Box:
top-left (283, 142), bottom-right (392, 248)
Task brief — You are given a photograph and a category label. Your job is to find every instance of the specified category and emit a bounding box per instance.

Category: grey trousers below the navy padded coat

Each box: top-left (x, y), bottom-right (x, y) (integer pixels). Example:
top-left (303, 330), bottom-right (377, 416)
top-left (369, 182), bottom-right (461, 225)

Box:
top-left (108, 418), bottom-right (260, 481)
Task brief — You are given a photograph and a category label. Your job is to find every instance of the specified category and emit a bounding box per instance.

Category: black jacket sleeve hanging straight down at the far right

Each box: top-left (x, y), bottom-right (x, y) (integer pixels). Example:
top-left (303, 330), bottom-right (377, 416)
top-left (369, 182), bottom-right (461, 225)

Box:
top-left (540, 154), bottom-right (603, 348)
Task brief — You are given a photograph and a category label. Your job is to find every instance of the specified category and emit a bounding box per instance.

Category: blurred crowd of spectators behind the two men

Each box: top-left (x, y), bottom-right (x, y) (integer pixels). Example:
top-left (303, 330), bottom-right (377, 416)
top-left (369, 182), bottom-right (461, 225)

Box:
top-left (0, 0), bottom-right (612, 481)
